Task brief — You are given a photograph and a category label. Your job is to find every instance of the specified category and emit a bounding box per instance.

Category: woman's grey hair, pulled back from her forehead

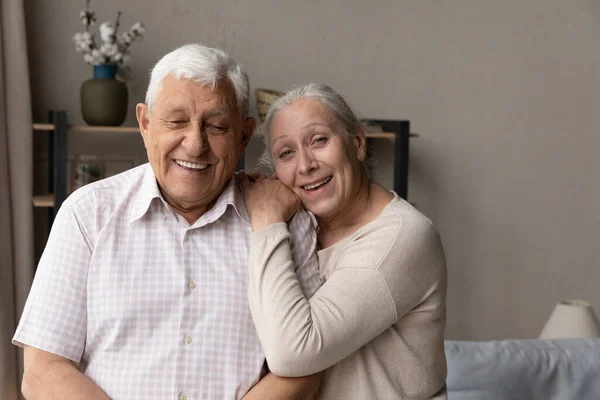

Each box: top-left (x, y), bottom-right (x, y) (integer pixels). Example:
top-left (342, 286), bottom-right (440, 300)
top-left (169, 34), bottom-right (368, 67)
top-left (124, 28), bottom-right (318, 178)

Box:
top-left (259, 83), bottom-right (364, 169)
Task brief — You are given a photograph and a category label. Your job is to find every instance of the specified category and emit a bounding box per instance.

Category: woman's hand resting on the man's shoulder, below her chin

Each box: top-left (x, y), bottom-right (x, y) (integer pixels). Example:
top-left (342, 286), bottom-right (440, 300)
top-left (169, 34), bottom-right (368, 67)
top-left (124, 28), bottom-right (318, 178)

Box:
top-left (237, 171), bottom-right (300, 231)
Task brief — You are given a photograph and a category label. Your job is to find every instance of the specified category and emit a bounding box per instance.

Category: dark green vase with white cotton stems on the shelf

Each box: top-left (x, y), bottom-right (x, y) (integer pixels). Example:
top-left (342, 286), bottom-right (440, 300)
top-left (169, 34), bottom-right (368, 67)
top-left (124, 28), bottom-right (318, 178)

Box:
top-left (73, 0), bottom-right (145, 126)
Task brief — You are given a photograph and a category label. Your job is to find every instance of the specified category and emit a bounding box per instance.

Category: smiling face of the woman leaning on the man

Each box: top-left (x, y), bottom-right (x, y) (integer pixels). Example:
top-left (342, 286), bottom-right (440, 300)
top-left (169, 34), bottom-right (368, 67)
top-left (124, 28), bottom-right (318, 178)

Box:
top-left (269, 99), bottom-right (366, 218)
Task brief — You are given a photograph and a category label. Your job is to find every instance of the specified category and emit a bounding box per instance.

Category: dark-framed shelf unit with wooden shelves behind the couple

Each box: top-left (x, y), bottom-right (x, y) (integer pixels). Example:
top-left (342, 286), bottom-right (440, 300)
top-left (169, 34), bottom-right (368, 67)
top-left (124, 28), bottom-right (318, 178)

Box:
top-left (33, 111), bottom-right (419, 219)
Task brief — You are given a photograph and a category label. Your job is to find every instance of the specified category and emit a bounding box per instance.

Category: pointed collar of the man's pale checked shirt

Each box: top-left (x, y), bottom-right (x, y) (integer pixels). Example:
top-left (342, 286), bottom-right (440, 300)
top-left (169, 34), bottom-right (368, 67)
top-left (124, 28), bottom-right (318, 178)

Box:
top-left (129, 164), bottom-right (250, 225)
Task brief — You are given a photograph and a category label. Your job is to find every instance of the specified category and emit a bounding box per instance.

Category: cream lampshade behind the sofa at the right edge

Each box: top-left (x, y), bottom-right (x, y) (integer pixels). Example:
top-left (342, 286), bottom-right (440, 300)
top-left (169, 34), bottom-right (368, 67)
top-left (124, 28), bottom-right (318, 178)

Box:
top-left (540, 300), bottom-right (600, 339)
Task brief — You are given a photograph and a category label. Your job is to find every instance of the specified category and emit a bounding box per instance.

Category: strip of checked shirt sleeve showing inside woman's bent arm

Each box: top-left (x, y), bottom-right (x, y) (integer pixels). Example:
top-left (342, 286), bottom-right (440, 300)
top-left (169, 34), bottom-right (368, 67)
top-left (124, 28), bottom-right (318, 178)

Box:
top-left (289, 209), bottom-right (322, 299)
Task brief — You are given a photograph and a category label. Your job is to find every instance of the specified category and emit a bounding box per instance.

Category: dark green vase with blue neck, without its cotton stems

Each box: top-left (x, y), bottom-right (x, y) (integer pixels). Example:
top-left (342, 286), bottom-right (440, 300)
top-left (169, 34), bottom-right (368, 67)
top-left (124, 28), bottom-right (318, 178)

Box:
top-left (81, 64), bottom-right (128, 126)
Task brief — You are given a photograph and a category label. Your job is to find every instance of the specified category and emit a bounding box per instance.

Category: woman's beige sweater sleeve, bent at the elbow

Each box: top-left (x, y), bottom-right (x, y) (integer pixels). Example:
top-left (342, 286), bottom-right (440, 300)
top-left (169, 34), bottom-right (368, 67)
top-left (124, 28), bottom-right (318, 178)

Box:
top-left (248, 219), bottom-right (440, 376)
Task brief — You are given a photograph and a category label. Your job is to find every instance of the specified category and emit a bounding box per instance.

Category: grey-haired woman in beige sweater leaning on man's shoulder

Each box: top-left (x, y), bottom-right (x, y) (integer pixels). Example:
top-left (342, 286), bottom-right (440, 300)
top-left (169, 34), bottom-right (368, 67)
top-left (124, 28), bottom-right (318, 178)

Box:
top-left (241, 84), bottom-right (446, 399)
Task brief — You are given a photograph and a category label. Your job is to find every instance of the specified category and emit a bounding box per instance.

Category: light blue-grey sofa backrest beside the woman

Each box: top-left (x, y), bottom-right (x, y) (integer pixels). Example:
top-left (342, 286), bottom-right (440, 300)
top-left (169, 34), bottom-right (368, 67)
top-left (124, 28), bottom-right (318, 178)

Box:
top-left (445, 339), bottom-right (600, 400)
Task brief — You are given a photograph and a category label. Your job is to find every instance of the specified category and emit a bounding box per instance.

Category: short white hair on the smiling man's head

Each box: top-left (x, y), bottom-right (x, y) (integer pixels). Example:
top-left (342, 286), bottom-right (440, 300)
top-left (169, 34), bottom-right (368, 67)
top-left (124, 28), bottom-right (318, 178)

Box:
top-left (146, 44), bottom-right (250, 117)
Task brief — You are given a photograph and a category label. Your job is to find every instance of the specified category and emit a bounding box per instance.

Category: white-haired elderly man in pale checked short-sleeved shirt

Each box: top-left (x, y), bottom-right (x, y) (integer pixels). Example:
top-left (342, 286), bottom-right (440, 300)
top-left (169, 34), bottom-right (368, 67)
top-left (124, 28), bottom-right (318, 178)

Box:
top-left (13, 45), bottom-right (320, 400)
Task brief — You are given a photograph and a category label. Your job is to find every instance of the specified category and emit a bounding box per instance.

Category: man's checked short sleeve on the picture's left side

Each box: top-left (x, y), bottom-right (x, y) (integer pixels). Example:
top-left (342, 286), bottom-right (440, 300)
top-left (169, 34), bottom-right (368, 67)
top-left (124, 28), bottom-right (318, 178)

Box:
top-left (13, 203), bottom-right (92, 362)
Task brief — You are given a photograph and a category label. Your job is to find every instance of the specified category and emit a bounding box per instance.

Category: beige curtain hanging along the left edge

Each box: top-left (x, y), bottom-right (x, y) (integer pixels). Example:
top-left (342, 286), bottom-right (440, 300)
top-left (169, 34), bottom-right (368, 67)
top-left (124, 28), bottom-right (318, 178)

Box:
top-left (0, 0), bottom-right (34, 400)
